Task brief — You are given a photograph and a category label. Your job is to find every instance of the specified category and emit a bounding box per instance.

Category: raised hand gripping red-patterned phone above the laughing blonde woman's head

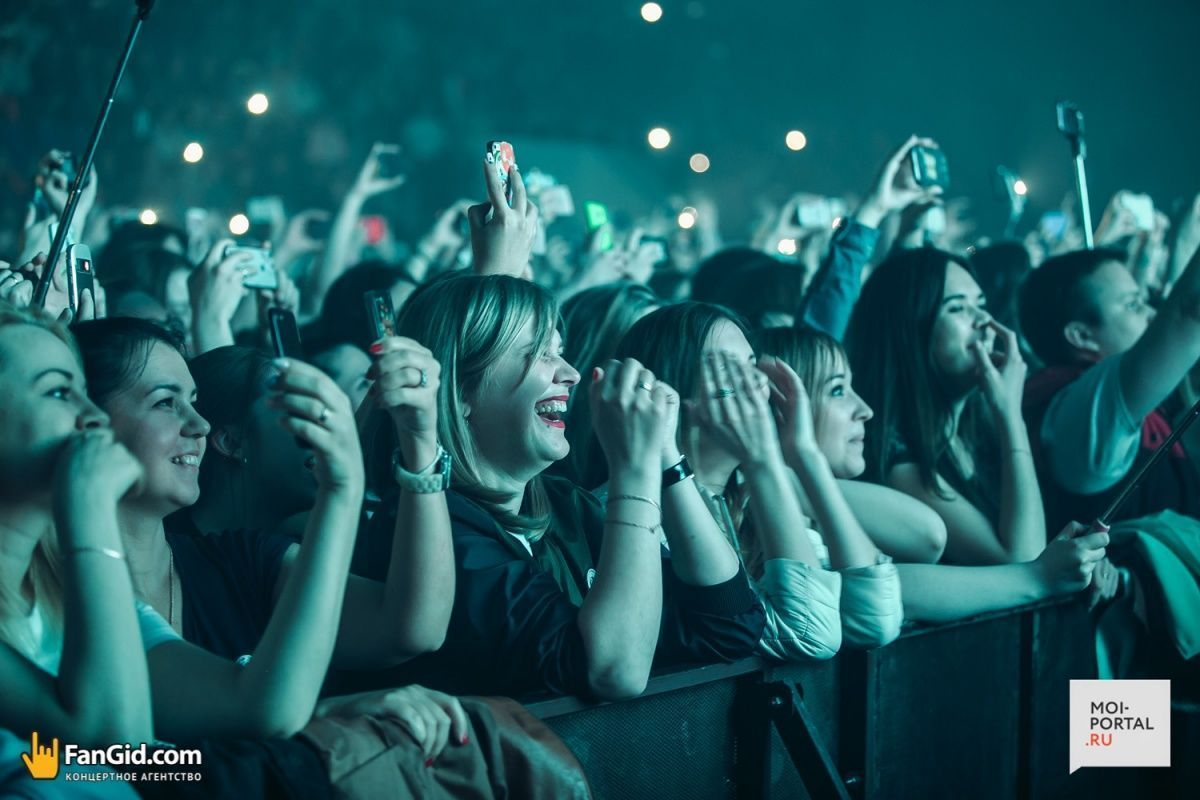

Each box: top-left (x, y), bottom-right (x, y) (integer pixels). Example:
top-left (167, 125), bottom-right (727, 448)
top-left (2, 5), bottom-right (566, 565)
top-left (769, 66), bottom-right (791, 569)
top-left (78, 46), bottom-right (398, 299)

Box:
top-left (467, 161), bottom-right (538, 277)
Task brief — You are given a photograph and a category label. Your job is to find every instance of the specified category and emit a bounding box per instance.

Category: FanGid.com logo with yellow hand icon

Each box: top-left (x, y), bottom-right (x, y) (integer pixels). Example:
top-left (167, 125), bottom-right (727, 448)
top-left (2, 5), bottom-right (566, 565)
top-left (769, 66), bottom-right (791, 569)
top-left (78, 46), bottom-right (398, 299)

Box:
top-left (20, 730), bottom-right (203, 782)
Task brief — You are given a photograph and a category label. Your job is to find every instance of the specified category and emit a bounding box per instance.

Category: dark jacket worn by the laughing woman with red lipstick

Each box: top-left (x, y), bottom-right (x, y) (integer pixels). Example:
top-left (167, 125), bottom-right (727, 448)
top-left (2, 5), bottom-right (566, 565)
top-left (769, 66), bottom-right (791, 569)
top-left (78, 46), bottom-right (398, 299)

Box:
top-left (347, 477), bottom-right (763, 697)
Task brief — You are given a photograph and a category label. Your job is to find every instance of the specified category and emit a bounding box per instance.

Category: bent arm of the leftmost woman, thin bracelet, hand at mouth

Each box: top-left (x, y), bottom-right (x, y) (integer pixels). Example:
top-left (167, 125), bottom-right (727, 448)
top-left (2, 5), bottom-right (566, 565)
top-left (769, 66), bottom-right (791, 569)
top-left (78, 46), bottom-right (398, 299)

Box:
top-left (0, 428), bottom-right (154, 747)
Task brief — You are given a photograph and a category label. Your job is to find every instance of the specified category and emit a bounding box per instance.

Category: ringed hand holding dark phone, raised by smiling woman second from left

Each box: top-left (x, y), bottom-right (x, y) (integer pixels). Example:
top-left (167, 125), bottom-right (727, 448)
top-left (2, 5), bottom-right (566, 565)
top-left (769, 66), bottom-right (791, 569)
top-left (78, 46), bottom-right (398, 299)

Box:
top-left (266, 359), bottom-right (364, 491)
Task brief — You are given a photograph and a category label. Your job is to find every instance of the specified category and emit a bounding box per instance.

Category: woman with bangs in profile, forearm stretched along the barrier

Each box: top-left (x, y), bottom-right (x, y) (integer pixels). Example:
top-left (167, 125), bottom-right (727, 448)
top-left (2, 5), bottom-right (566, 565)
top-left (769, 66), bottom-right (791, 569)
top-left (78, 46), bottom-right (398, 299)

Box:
top-left (758, 321), bottom-right (1106, 622)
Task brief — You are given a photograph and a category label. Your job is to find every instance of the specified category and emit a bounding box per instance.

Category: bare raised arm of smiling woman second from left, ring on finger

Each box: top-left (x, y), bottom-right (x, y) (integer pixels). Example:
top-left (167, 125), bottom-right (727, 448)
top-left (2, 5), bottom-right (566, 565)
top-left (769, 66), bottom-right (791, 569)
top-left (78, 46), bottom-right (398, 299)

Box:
top-left (149, 361), bottom-right (364, 739)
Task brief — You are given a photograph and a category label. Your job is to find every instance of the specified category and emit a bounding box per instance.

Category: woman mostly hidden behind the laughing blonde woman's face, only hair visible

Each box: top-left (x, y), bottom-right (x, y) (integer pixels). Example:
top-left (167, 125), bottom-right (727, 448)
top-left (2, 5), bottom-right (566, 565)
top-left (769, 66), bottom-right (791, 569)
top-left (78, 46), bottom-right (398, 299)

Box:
top-left (552, 281), bottom-right (662, 489)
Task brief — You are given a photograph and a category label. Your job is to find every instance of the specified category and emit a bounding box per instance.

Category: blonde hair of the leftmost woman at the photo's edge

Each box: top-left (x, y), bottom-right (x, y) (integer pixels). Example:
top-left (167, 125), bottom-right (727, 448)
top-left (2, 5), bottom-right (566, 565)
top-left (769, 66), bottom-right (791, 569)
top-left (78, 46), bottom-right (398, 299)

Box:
top-left (0, 302), bottom-right (79, 652)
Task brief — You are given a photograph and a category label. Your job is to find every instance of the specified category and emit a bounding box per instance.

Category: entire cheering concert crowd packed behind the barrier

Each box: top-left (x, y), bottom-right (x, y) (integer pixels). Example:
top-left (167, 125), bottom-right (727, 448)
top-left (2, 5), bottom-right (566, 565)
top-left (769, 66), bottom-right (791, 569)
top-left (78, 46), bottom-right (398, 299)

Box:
top-left (0, 128), bottom-right (1200, 798)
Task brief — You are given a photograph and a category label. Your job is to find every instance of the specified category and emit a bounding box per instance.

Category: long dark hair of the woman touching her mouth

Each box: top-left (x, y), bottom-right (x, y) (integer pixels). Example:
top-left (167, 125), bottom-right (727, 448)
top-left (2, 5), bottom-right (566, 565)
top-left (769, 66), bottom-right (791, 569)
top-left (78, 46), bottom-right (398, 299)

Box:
top-left (846, 247), bottom-right (998, 513)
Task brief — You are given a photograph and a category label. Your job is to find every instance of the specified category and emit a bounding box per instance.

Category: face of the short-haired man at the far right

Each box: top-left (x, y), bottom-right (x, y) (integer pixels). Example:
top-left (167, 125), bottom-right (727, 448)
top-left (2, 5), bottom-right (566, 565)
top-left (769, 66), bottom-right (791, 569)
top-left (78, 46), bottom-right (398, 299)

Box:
top-left (1067, 261), bottom-right (1154, 361)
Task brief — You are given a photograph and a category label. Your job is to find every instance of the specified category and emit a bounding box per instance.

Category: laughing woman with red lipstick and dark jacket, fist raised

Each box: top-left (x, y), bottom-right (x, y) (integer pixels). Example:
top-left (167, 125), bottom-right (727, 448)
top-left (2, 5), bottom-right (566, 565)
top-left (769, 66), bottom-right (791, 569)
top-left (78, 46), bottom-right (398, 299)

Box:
top-left (352, 273), bottom-right (762, 698)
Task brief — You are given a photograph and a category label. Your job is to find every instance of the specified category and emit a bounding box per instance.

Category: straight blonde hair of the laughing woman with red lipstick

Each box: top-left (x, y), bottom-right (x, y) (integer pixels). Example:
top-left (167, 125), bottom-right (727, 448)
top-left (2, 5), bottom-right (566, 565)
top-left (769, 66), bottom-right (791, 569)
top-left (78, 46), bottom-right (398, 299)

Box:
top-left (396, 272), bottom-right (558, 541)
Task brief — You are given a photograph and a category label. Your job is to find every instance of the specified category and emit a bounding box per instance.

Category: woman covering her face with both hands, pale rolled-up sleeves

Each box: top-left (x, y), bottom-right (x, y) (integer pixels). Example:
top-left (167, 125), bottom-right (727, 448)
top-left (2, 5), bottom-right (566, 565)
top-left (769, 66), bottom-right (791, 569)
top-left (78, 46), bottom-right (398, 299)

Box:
top-left (618, 302), bottom-right (902, 658)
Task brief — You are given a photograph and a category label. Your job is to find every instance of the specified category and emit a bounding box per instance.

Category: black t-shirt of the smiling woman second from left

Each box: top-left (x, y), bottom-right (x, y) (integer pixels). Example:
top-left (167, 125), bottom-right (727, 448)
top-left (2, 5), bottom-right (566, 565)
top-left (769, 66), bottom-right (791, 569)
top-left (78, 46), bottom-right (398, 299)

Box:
top-left (167, 522), bottom-right (298, 660)
